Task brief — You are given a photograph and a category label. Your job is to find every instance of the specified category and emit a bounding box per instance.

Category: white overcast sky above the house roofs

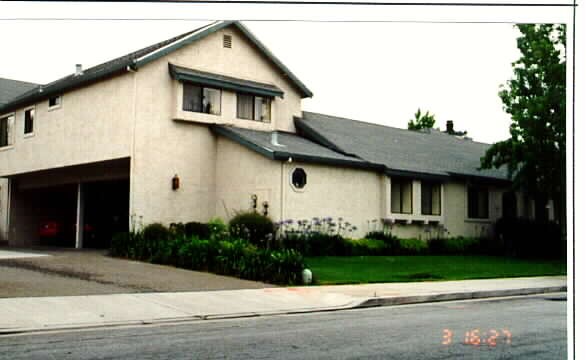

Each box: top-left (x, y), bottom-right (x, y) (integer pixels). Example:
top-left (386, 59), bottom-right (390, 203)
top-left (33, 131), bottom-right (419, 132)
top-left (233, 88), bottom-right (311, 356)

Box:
top-left (0, 1), bottom-right (569, 143)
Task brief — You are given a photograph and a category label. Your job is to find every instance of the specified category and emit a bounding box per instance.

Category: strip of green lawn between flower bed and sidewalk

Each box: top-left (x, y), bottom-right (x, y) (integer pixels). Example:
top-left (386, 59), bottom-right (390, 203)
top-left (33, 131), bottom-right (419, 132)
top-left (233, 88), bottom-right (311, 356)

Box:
top-left (305, 256), bottom-right (566, 285)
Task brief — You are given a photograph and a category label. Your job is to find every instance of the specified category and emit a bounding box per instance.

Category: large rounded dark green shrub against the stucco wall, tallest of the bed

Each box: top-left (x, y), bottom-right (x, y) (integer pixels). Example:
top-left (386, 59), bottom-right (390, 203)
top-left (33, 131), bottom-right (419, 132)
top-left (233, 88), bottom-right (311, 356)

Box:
top-left (229, 212), bottom-right (275, 247)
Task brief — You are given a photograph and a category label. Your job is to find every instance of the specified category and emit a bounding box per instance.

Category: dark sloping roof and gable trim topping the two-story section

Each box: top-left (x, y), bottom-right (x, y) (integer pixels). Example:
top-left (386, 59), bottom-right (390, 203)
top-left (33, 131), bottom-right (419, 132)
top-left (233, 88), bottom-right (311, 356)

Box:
top-left (0, 21), bottom-right (313, 113)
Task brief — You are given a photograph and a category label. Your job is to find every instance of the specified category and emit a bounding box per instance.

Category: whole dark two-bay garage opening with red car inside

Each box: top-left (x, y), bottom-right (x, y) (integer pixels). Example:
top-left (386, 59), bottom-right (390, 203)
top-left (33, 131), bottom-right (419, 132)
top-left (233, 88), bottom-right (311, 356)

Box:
top-left (9, 159), bottom-right (130, 248)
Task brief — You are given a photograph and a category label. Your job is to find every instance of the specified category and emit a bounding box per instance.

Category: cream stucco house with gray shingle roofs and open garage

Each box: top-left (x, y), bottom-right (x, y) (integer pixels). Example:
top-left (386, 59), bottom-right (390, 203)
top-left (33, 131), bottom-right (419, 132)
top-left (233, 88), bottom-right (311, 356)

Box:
top-left (0, 21), bottom-right (532, 247)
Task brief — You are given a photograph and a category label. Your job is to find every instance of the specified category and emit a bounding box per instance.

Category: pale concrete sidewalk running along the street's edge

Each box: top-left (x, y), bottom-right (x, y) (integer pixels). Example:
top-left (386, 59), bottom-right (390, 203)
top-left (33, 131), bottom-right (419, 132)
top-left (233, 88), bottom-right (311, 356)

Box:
top-left (0, 276), bottom-right (567, 335)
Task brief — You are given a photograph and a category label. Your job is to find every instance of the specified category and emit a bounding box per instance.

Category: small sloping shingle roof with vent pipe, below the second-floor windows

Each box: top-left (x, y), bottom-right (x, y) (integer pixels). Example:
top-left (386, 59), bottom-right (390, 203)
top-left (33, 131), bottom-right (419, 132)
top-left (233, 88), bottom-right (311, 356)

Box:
top-left (212, 125), bottom-right (380, 170)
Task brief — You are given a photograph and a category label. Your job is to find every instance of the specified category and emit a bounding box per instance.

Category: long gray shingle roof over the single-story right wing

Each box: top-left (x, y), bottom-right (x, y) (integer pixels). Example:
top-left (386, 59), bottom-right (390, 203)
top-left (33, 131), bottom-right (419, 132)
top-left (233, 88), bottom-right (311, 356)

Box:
top-left (295, 112), bottom-right (507, 180)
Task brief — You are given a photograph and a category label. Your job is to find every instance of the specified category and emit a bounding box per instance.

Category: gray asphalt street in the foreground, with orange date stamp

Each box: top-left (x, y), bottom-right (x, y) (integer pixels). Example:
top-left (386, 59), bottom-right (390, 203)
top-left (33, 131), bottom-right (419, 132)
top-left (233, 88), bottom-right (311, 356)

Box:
top-left (0, 293), bottom-right (568, 360)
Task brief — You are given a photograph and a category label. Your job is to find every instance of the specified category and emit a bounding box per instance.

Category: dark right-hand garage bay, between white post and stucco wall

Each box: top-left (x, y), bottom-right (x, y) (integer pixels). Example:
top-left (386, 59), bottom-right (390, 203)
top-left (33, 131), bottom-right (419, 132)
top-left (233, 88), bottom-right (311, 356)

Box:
top-left (82, 179), bottom-right (130, 249)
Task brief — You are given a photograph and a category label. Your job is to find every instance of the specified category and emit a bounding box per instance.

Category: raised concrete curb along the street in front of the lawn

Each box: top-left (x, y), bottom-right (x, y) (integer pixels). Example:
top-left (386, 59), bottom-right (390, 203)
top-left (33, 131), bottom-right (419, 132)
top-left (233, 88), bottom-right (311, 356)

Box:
top-left (356, 286), bottom-right (568, 308)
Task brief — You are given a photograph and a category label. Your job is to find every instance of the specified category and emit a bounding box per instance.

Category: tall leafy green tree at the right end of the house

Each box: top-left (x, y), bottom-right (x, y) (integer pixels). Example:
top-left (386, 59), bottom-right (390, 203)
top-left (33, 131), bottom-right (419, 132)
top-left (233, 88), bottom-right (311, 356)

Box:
top-left (481, 24), bottom-right (566, 222)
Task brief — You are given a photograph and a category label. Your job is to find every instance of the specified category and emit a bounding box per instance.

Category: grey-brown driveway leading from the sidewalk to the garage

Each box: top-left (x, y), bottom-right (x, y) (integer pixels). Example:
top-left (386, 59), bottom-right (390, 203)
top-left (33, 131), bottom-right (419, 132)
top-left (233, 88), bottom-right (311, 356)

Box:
top-left (0, 248), bottom-right (273, 298)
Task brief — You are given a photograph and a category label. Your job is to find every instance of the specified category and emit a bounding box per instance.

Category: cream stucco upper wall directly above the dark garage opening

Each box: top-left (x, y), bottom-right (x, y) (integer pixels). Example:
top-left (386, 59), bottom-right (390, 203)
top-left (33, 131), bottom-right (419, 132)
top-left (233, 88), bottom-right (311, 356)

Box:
top-left (0, 75), bottom-right (133, 176)
